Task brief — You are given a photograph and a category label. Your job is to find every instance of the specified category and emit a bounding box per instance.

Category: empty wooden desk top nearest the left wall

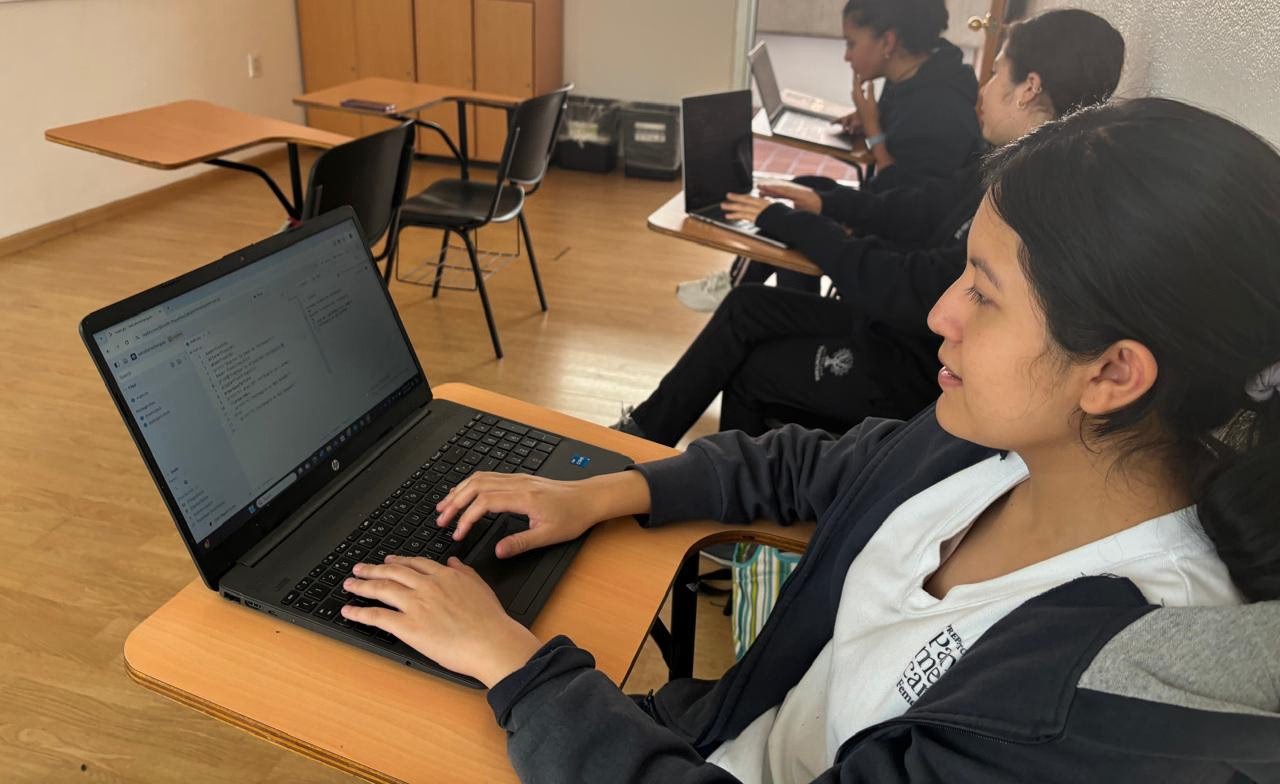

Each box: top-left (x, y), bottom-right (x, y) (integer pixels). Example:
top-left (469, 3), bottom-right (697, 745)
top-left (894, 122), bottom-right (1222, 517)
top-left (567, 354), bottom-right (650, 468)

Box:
top-left (45, 101), bottom-right (351, 169)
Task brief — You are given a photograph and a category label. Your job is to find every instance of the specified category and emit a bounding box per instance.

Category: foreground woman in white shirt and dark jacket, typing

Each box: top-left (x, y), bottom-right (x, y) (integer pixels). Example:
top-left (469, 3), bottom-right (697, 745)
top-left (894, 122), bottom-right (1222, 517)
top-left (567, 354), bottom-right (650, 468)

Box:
top-left (343, 99), bottom-right (1280, 784)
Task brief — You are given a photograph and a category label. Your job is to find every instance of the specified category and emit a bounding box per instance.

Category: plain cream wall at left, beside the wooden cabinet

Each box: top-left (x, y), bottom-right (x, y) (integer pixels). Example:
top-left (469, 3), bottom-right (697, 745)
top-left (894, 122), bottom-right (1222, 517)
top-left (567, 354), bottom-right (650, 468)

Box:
top-left (0, 0), bottom-right (302, 237)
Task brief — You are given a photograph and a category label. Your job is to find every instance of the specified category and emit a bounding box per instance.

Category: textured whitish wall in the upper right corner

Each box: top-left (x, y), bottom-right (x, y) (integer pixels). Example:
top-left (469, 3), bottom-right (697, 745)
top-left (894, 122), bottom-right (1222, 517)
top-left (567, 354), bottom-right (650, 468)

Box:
top-left (1029, 0), bottom-right (1280, 145)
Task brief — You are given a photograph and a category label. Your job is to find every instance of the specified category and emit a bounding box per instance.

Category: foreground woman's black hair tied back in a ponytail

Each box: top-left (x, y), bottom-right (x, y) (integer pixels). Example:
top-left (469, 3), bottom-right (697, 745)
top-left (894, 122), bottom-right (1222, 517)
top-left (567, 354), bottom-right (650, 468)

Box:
top-left (986, 99), bottom-right (1280, 601)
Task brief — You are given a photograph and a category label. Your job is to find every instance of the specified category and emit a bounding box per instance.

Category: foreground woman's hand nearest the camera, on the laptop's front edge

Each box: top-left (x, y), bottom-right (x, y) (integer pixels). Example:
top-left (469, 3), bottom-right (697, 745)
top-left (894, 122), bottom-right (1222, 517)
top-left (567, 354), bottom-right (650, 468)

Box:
top-left (342, 556), bottom-right (541, 687)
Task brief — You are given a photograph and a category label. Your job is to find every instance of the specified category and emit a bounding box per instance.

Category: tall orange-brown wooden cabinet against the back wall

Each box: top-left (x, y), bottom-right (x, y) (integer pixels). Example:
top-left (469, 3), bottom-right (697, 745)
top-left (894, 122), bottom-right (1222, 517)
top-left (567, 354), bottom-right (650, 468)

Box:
top-left (297, 0), bottom-right (564, 161)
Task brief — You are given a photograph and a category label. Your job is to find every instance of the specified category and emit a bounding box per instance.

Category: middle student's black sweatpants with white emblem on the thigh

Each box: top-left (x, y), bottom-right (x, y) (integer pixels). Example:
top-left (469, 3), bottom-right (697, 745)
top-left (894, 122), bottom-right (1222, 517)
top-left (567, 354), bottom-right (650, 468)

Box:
top-left (632, 286), bottom-right (937, 446)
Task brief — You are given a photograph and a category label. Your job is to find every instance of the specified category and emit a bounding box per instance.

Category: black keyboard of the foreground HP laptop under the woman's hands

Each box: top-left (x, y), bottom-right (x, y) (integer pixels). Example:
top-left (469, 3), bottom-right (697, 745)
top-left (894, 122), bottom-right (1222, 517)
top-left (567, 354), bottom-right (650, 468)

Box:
top-left (280, 414), bottom-right (561, 644)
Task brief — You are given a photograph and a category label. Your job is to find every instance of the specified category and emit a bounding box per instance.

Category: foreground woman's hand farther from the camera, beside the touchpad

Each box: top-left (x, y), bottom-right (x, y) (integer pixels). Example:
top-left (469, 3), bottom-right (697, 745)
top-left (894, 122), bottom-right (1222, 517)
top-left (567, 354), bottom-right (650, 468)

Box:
top-left (435, 471), bottom-right (649, 559)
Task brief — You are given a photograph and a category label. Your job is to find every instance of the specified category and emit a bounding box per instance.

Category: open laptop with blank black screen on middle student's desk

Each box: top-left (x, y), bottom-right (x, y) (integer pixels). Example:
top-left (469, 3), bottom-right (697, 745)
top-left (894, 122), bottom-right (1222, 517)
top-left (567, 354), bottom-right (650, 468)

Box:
top-left (680, 90), bottom-right (786, 247)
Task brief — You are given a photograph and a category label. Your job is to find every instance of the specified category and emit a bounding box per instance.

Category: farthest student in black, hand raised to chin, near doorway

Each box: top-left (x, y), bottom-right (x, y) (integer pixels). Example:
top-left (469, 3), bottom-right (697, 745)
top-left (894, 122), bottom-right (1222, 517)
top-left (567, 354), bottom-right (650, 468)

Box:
top-left (676, 0), bottom-right (986, 311)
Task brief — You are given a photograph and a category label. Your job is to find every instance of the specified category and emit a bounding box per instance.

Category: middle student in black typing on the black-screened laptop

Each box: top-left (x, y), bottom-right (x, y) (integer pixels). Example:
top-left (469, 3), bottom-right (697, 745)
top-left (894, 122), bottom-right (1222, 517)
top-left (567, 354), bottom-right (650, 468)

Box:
top-left (614, 9), bottom-right (1124, 446)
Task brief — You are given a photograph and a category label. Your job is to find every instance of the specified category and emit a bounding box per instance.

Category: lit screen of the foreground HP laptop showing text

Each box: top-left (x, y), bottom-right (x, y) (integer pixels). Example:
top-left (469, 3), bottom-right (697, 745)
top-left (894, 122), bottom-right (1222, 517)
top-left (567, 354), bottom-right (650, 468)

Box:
top-left (93, 220), bottom-right (421, 542)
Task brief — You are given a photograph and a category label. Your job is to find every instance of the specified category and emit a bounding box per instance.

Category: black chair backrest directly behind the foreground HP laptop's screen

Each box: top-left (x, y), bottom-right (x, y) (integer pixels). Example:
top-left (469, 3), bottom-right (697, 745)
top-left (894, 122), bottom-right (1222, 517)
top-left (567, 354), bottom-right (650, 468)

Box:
top-left (302, 120), bottom-right (413, 247)
